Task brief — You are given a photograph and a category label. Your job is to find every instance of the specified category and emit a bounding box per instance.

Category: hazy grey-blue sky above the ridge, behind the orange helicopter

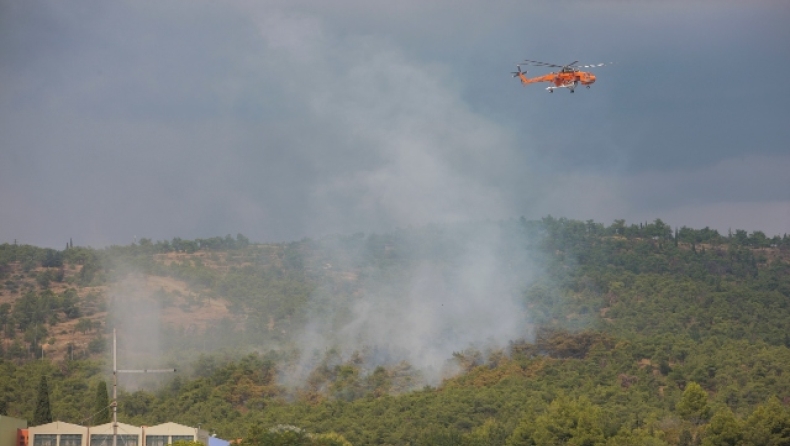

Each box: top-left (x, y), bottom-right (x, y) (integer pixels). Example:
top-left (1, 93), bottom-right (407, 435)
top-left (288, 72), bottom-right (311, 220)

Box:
top-left (0, 0), bottom-right (790, 248)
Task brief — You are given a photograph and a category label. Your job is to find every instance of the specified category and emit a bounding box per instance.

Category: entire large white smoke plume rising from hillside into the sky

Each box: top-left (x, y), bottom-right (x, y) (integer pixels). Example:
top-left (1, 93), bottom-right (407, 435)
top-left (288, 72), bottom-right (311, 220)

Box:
top-left (248, 14), bottom-right (540, 383)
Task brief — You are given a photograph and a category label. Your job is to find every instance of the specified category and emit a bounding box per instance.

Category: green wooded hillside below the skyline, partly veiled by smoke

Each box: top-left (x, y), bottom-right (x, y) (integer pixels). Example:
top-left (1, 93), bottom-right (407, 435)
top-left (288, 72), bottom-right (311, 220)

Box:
top-left (0, 217), bottom-right (790, 446)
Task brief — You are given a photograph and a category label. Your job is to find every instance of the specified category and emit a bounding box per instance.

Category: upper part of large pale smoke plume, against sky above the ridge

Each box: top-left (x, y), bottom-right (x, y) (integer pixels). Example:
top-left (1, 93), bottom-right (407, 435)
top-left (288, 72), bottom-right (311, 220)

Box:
top-left (251, 14), bottom-right (528, 234)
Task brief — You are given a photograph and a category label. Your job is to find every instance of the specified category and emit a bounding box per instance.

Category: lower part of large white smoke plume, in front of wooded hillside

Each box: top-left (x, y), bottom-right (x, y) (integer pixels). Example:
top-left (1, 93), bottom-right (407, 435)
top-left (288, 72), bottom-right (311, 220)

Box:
top-left (287, 223), bottom-right (534, 385)
